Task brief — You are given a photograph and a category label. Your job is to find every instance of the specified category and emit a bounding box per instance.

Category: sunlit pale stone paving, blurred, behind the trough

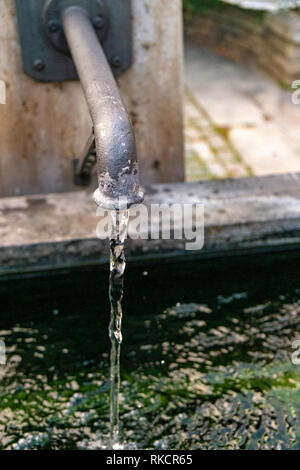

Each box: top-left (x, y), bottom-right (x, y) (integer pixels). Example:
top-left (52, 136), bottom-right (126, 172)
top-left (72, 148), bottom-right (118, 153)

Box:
top-left (185, 44), bottom-right (300, 181)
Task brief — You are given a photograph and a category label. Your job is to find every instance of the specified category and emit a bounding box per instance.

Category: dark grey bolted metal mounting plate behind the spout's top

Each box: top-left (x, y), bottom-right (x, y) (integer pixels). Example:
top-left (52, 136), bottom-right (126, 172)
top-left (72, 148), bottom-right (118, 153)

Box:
top-left (15, 0), bottom-right (132, 82)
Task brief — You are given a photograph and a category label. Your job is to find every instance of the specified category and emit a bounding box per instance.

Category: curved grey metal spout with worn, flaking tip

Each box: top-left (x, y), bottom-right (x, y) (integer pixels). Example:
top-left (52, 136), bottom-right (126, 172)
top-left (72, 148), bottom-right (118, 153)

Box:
top-left (62, 6), bottom-right (143, 210)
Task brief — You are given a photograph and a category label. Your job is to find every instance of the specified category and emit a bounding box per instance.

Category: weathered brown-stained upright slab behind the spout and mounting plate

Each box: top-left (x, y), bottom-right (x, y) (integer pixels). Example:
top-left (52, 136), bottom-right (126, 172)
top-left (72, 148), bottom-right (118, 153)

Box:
top-left (0, 0), bottom-right (183, 197)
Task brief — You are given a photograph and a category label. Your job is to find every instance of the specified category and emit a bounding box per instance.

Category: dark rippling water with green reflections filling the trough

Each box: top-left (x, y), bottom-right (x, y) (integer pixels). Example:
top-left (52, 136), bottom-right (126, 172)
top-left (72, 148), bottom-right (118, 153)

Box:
top-left (0, 252), bottom-right (300, 449)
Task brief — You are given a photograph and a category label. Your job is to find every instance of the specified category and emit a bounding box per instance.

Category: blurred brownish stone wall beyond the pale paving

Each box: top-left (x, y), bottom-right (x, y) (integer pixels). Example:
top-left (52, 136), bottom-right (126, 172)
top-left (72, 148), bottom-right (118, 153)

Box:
top-left (185, 5), bottom-right (300, 86)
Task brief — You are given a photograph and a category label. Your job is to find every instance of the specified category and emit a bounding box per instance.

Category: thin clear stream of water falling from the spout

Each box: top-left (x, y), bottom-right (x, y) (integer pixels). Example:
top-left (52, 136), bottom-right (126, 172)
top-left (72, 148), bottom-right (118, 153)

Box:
top-left (109, 210), bottom-right (129, 448)
